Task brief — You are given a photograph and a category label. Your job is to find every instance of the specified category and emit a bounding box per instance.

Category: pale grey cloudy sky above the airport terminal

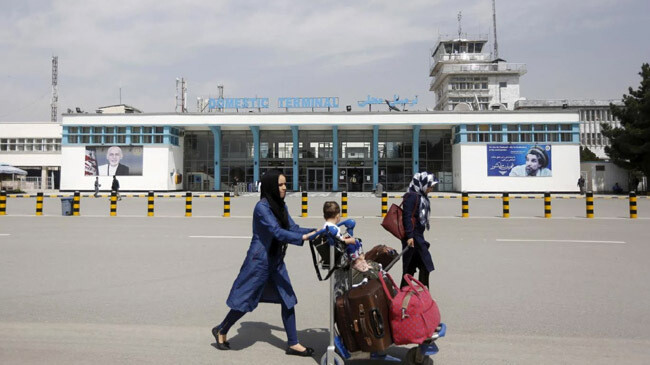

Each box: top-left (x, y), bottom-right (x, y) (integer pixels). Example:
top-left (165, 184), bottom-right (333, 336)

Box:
top-left (0, 0), bottom-right (650, 121)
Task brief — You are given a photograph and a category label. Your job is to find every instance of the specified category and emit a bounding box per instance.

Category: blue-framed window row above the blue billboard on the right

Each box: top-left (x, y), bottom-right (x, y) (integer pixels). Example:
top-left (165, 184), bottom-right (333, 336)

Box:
top-left (454, 124), bottom-right (578, 143)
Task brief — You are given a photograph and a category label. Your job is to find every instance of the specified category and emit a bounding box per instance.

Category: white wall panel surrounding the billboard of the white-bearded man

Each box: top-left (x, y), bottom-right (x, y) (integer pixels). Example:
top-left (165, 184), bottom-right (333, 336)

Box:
top-left (60, 145), bottom-right (183, 191)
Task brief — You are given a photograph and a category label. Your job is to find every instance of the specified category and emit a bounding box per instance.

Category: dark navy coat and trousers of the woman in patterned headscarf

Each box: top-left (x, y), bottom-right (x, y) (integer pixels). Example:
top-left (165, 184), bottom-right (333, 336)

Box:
top-left (400, 192), bottom-right (434, 287)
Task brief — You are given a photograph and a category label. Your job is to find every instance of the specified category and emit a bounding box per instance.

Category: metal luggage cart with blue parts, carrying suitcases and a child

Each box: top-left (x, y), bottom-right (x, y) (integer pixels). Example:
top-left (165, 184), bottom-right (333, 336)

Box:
top-left (309, 219), bottom-right (440, 365)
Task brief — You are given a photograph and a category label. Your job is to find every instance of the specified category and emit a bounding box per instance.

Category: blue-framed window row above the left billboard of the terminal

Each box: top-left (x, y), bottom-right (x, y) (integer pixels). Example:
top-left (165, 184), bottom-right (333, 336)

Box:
top-left (63, 126), bottom-right (180, 146)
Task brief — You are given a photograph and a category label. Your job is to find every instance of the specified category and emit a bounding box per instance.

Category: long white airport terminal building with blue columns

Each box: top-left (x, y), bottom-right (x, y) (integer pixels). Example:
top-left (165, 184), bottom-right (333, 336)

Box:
top-left (60, 109), bottom-right (580, 192)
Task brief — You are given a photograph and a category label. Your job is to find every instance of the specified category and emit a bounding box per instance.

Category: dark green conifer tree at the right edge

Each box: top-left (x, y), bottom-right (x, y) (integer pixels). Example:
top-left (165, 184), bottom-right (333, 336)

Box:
top-left (601, 63), bottom-right (650, 176)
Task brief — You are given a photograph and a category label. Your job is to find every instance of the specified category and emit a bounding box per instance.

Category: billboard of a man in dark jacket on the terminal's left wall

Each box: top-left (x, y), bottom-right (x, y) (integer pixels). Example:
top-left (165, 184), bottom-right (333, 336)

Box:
top-left (84, 146), bottom-right (142, 176)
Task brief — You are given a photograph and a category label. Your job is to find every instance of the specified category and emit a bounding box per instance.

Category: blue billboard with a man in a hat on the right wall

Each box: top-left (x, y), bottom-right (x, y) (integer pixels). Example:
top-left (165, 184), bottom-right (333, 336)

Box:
top-left (487, 144), bottom-right (553, 176)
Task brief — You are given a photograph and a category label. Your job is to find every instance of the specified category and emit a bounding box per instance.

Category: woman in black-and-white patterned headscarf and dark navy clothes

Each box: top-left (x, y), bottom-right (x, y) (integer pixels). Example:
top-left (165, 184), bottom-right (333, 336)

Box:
top-left (400, 172), bottom-right (438, 287)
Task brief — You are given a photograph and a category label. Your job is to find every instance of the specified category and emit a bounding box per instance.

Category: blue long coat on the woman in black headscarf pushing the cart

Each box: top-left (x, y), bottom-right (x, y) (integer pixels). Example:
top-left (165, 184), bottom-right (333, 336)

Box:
top-left (226, 199), bottom-right (312, 312)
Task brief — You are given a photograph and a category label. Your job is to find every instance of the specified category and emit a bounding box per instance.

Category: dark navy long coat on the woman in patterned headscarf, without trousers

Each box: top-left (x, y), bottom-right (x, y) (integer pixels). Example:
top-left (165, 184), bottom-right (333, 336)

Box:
top-left (402, 193), bottom-right (434, 272)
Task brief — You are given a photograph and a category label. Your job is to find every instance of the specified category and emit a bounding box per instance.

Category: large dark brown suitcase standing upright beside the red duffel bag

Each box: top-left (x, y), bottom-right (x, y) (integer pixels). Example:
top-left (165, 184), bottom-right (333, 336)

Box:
top-left (335, 279), bottom-right (393, 352)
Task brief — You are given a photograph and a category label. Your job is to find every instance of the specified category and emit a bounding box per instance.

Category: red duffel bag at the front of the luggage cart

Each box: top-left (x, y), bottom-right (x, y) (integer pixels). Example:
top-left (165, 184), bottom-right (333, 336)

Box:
top-left (379, 273), bottom-right (440, 345)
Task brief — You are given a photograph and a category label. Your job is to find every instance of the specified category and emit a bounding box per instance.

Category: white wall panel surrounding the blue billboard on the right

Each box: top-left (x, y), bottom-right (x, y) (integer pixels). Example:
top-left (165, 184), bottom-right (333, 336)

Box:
top-left (453, 144), bottom-right (580, 193)
